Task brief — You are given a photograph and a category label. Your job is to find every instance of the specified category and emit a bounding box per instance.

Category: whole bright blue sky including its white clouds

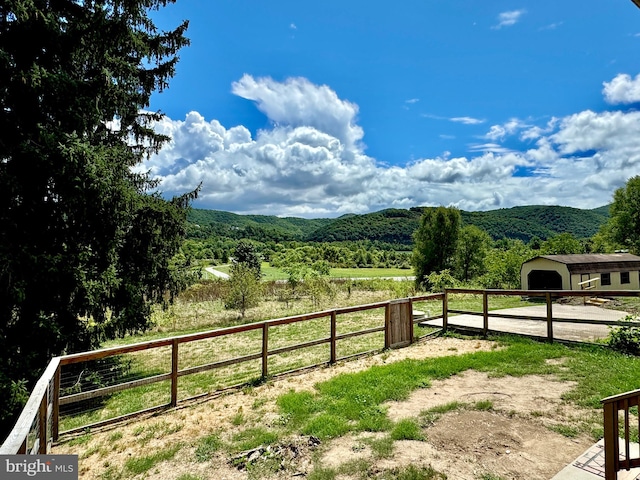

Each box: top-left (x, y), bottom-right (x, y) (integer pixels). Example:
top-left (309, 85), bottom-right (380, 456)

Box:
top-left (143, 0), bottom-right (640, 217)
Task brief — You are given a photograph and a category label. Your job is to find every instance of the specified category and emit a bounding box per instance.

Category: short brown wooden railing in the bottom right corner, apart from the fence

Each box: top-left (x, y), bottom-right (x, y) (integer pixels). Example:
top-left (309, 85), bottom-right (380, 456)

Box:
top-left (601, 390), bottom-right (640, 480)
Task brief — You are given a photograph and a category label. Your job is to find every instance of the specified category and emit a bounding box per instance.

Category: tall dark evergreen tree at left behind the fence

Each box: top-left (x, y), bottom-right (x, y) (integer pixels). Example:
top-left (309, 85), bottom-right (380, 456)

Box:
top-left (0, 0), bottom-right (195, 433)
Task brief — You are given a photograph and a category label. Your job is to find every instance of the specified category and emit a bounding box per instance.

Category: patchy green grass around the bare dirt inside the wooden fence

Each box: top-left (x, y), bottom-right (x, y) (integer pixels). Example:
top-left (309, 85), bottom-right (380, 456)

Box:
top-left (60, 336), bottom-right (640, 480)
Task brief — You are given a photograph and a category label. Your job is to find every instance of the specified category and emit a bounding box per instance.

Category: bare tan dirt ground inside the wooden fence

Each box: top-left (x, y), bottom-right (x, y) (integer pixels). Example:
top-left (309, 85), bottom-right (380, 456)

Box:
top-left (53, 338), bottom-right (593, 480)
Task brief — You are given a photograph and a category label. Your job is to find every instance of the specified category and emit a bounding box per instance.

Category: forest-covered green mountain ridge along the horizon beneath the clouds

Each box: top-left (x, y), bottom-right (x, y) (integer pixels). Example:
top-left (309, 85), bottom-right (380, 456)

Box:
top-left (188, 205), bottom-right (609, 245)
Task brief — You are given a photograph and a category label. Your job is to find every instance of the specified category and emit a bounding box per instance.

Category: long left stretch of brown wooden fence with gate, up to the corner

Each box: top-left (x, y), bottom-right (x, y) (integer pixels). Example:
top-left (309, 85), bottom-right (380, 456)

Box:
top-left (0, 294), bottom-right (444, 455)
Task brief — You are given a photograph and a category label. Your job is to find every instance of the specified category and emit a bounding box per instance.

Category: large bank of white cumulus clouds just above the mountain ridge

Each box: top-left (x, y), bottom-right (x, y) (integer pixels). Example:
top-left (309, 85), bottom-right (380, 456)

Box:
top-left (139, 75), bottom-right (640, 217)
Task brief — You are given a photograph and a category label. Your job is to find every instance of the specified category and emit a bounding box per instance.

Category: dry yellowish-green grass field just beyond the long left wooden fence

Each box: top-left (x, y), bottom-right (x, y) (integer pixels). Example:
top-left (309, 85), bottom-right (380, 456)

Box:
top-left (61, 279), bottom-right (544, 431)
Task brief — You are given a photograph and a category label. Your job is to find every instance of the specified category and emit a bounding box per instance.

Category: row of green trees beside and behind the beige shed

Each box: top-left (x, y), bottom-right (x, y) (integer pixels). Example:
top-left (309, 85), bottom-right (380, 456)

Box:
top-left (412, 181), bottom-right (640, 290)
